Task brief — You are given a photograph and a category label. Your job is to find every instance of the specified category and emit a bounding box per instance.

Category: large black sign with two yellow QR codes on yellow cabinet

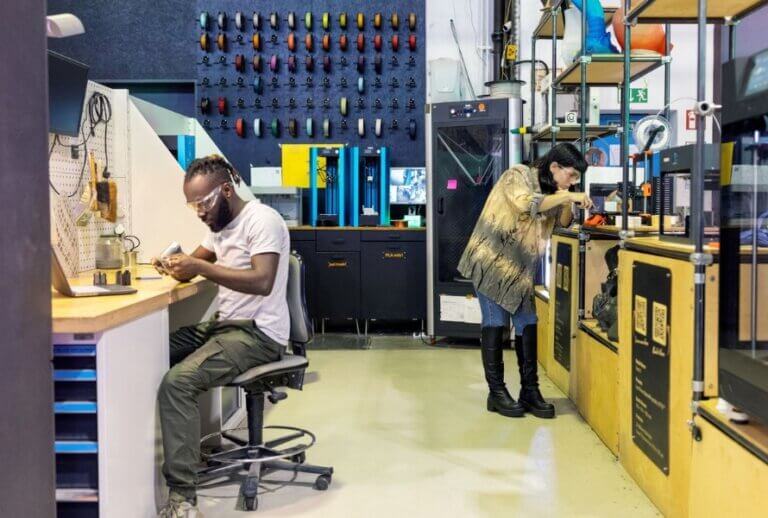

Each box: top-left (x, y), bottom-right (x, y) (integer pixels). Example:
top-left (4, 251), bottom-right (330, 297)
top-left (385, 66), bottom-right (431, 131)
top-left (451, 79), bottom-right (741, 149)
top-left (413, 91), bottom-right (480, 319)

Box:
top-left (632, 263), bottom-right (672, 475)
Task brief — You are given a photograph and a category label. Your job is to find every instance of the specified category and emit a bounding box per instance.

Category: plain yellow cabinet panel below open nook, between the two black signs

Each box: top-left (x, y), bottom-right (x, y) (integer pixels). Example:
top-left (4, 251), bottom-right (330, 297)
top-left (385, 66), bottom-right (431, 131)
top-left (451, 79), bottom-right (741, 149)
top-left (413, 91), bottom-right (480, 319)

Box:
top-left (574, 320), bottom-right (619, 457)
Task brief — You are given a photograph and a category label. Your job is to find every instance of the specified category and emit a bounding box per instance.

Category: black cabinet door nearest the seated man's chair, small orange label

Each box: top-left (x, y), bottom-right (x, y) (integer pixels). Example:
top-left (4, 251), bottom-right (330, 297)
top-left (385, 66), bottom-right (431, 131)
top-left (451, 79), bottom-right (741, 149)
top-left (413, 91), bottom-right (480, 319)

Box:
top-left (315, 252), bottom-right (360, 320)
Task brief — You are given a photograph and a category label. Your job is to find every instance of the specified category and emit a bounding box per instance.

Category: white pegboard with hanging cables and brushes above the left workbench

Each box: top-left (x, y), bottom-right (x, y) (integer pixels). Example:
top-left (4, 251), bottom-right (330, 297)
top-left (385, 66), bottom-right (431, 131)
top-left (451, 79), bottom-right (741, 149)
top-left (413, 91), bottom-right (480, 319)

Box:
top-left (48, 81), bottom-right (131, 276)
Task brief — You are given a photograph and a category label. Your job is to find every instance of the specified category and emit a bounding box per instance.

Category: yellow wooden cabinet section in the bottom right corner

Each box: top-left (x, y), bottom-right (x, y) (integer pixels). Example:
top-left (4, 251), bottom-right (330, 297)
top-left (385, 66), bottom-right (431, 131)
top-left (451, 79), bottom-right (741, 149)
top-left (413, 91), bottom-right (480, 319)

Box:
top-left (690, 399), bottom-right (768, 518)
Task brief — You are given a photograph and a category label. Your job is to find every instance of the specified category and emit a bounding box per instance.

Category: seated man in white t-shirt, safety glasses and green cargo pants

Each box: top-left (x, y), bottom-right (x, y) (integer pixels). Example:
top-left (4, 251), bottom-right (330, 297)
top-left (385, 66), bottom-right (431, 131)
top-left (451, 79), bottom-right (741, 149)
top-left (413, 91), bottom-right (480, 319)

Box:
top-left (153, 156), bottom-right (290, 518)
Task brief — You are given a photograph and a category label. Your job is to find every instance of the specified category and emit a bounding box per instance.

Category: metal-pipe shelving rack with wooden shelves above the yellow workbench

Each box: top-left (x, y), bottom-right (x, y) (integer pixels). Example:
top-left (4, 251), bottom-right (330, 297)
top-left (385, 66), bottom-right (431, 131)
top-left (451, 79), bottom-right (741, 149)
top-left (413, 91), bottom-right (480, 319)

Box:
top-left (531, 0), bottom-right (768, 418)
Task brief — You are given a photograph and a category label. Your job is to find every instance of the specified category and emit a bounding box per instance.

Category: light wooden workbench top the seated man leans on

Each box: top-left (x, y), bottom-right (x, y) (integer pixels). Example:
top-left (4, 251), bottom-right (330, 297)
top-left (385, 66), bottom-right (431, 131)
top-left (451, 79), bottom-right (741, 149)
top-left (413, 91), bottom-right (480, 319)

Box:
top-left (51, 266), bottom-right (214, 333)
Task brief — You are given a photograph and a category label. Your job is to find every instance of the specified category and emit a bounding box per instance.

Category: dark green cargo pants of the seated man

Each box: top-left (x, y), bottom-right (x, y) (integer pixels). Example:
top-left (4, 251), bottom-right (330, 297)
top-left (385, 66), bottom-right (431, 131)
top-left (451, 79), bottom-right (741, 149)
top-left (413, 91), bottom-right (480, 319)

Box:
top-left (158, 320), bottom-right (283, 500)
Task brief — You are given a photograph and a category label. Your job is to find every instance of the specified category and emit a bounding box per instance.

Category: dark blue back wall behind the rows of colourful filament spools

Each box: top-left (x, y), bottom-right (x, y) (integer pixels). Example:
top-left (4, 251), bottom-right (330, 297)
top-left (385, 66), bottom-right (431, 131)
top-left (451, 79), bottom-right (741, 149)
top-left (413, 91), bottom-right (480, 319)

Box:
top-left (48, 0), bottom-right (427, 183)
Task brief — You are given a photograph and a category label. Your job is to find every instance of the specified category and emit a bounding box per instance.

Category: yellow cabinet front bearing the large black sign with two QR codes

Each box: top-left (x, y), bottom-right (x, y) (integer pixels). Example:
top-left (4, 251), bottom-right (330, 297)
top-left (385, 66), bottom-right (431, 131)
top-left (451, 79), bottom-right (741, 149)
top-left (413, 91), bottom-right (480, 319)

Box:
top-left (618, 237), bottom-right (718, 518)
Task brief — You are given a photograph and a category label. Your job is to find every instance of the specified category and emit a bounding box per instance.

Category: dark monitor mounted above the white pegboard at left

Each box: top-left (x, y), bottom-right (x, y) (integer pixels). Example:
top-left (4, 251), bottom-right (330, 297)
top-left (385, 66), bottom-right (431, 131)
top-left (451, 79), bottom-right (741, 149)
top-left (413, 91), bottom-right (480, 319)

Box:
top-left (48, 50), bottom-right (88, 137)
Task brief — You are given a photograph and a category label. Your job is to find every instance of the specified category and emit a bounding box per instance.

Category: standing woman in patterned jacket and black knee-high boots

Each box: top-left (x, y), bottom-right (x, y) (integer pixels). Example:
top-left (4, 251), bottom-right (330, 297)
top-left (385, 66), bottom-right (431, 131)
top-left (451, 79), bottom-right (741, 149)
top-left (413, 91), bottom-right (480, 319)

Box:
top-left (459, 144), bottom-right (592, 418)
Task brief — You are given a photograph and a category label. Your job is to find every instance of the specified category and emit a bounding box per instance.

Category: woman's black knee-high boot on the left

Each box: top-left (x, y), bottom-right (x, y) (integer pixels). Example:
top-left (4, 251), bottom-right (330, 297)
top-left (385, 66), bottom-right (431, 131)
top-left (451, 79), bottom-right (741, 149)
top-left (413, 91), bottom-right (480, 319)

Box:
top-left (481, 327), bottom-right (525, 417)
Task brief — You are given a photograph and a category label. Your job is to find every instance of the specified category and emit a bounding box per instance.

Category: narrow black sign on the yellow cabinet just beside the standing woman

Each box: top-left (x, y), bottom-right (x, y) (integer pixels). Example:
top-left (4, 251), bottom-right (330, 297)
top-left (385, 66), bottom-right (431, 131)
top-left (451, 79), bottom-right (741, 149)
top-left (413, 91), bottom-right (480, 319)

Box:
top-left (550, 243), bottom-right (573, 371)
